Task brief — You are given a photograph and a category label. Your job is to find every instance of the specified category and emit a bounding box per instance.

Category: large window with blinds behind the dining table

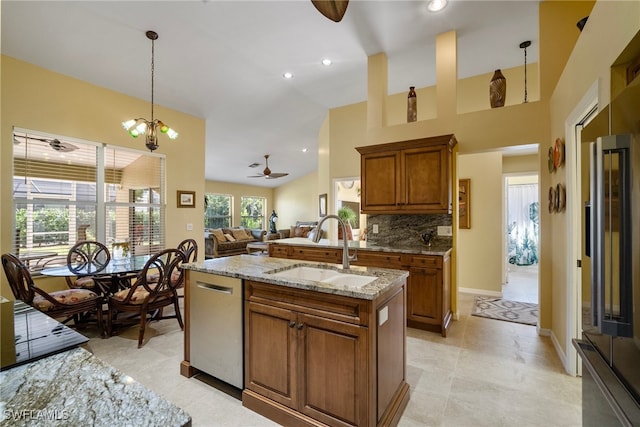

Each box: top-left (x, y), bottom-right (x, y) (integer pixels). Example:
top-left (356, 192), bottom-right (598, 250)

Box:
top-left (12, 130), bottom-right (164, 270)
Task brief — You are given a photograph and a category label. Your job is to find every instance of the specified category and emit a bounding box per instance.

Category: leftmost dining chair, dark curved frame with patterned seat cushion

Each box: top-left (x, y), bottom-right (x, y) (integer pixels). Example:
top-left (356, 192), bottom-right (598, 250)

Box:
top-left (2, 253), bottom-right (104, 336)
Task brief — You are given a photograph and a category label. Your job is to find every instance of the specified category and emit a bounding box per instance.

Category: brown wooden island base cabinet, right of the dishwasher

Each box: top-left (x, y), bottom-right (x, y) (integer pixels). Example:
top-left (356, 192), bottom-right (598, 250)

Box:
top-left (242, 281), bottom-right (409, 426)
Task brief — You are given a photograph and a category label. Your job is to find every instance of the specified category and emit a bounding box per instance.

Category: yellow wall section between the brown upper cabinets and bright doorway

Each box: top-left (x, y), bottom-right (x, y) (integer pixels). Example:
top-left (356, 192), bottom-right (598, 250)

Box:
top-left (457, 151), bottom-right (504, 296)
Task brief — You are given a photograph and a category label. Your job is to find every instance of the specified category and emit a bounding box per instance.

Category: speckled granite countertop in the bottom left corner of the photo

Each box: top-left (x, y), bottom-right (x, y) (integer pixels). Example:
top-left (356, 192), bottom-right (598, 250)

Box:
top-left (0, 348), bottom-right (191, 427)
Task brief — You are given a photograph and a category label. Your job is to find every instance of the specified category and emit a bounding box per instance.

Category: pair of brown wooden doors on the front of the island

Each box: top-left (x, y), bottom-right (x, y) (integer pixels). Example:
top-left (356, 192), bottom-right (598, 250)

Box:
top-left (245, 302), bottom-right (368, 426)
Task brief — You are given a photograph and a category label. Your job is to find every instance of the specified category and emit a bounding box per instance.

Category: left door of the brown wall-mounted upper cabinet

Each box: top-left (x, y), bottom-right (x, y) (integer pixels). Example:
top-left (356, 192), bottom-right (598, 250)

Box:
top-left (360, 151), bottom-right (401, 212)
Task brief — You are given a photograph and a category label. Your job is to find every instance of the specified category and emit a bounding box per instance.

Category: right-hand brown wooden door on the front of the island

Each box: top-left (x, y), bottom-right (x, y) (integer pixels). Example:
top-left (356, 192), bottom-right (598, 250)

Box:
top-left (296, 314), bottom-right (368, 426)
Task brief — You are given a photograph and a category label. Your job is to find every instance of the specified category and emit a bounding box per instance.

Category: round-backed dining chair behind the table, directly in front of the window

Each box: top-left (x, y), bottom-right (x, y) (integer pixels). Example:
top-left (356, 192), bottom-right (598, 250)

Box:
top-left (65, 240), bottom-right (111, 294)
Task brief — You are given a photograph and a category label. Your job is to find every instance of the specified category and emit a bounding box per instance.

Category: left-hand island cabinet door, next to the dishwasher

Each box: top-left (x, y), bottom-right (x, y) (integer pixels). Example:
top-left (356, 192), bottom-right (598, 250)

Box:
top-left (245, 302), bottom-right (299, 408)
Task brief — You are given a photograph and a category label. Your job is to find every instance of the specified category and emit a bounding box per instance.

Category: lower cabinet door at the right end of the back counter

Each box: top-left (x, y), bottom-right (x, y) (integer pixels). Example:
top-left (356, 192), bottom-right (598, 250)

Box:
top-left (407, 267), bottom-right (442, 325)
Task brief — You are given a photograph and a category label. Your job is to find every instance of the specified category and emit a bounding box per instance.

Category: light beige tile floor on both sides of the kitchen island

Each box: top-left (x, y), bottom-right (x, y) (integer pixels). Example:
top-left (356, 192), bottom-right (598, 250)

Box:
top-left (88, 294), bottom-right (581, 427)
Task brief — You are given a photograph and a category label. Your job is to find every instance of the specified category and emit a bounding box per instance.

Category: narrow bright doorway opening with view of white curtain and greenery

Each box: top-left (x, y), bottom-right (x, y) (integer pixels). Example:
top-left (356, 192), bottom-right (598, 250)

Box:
top-left (502, 174), bottom-right (540, 304)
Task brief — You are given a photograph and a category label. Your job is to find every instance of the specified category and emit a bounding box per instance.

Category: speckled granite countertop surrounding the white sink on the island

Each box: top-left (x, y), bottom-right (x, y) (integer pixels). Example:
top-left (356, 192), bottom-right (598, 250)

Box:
top-left (184, 255), bottom-right (409, 300)
